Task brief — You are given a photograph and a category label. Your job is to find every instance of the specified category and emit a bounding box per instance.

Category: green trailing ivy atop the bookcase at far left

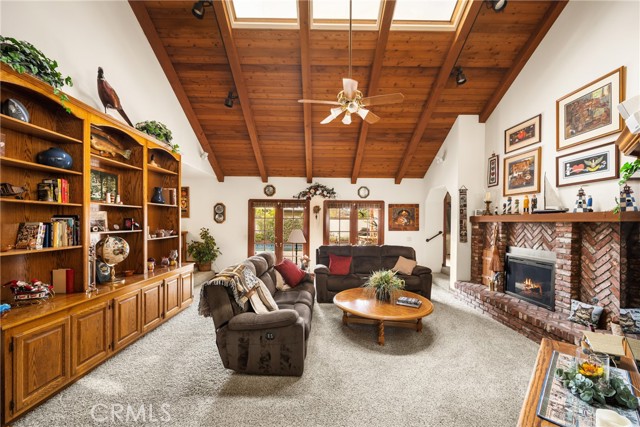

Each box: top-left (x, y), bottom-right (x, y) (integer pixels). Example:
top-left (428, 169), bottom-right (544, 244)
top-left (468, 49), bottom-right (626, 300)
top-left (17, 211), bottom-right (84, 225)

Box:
top-left (0, 36), bottom-right (73, 112)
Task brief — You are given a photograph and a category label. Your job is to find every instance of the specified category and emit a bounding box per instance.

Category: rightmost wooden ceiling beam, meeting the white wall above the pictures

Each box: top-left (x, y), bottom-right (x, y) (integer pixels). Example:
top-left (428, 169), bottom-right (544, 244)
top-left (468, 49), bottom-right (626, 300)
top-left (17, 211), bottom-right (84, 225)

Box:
top-left (480, 0), bottom-right (569, 123)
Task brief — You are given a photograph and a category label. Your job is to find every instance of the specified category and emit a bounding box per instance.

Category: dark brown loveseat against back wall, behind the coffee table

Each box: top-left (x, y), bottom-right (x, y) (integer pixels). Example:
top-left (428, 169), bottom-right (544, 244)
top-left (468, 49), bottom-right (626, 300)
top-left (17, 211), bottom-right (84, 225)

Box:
top-left (314, 245), bottom-right (432, 302)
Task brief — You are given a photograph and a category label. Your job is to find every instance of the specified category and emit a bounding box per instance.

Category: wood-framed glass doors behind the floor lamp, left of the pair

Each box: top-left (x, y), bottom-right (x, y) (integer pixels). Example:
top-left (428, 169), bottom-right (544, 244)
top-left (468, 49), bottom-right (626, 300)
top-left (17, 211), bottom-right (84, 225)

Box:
top-left (247, 199), bottom-right (309, 264)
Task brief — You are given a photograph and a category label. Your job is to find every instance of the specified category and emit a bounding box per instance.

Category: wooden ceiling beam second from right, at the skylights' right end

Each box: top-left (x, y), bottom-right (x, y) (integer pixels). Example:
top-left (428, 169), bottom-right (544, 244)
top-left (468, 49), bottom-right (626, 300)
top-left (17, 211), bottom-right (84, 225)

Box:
top-left (395, 0), bottom-right (484, 184)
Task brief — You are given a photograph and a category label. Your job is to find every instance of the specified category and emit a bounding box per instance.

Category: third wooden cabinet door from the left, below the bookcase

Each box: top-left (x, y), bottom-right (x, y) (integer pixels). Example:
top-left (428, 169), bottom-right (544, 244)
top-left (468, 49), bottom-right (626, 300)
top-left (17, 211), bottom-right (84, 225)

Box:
top-left (113, 290), bottom-right (142, 350)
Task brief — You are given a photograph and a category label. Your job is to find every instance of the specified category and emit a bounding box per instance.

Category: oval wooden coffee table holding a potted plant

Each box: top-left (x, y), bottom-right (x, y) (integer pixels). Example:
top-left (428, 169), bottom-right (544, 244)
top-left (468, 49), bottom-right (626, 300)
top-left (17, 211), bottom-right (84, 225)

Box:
top-left (333, 288), bottom-right (433, 345)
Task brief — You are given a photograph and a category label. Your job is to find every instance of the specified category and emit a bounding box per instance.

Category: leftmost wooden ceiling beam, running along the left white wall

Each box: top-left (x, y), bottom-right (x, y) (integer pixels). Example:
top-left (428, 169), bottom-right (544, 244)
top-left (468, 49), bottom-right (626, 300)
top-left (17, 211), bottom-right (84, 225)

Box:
top-left (129, 0), bottom-right (224, 182)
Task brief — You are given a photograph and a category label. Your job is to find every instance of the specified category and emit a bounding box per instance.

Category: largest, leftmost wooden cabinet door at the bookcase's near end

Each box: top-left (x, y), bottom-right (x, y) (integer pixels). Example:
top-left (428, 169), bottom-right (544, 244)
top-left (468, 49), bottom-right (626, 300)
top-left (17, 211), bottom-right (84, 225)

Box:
top-left (13, 317), bottom-right (71, 412)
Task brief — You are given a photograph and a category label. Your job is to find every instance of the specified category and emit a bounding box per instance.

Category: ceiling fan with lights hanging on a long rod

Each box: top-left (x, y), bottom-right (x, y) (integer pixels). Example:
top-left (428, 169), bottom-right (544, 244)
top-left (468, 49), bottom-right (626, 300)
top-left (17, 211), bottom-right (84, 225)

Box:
top-left (298, 0), bottom-right (404, 125)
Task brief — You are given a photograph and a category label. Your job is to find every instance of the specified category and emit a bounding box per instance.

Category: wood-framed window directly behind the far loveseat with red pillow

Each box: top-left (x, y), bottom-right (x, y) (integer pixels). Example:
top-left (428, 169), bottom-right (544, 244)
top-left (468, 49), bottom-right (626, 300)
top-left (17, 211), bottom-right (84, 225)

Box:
top-left (323, 200), bottom-right (384, 246)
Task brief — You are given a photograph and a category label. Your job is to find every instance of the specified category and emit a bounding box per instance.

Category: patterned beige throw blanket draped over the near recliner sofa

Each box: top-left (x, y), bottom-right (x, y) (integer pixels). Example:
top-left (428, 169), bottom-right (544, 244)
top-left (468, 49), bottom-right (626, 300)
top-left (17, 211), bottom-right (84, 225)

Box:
top-left (198, 264), bottom-right (278, 317)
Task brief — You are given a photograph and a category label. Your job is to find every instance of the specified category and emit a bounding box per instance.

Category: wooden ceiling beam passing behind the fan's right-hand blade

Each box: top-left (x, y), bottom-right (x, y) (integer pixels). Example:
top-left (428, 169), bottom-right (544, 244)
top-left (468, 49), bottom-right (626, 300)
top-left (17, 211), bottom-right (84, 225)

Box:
top-left (351, 0), bottom-right (396, 184)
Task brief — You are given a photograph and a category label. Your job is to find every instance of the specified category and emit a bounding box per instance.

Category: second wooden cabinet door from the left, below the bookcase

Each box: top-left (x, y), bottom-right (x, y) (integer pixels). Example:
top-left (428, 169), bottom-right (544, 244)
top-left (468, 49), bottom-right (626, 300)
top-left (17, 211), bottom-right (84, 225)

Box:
top-left (71, 301), bottom-right (111, 375)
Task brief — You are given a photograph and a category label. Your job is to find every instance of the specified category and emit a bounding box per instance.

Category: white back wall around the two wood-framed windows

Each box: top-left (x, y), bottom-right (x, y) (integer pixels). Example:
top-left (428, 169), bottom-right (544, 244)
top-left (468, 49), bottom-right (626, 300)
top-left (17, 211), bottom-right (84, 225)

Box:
top-left (182, 176), bottom-right (430, 269)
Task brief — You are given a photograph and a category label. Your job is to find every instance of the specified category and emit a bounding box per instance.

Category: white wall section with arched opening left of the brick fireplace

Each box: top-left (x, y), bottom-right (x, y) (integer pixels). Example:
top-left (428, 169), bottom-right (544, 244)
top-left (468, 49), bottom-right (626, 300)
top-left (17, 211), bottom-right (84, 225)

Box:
top-left (424, 116), bottom-right (485, 283)
